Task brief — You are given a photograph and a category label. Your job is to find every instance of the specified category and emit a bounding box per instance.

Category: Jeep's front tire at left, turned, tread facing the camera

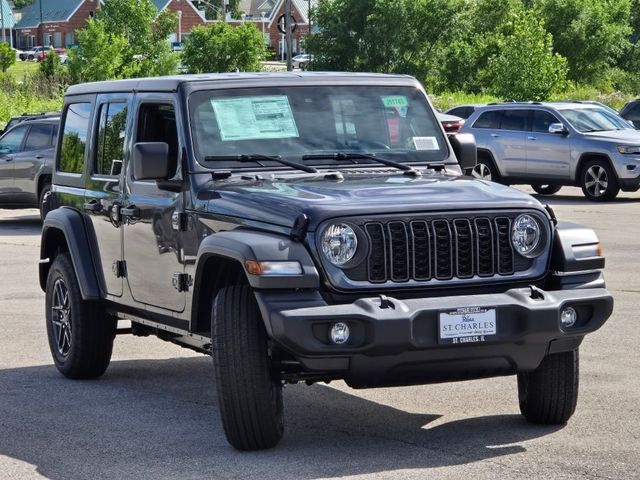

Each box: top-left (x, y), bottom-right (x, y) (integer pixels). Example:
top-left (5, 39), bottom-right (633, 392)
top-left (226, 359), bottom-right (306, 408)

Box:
top-left (211, 285), bottom-right (284, 450)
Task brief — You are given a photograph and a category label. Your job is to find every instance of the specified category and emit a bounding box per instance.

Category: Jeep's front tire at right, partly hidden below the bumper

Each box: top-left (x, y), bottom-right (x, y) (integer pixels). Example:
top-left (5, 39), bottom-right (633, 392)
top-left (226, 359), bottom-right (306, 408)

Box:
top-left (518, 349), bottom-right (579, 424)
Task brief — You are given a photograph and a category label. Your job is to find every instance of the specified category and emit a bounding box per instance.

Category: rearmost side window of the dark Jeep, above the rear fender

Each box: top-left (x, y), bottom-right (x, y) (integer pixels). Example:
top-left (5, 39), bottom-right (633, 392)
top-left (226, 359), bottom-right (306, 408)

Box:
top-left (58, 103), bottom-right (91, 173)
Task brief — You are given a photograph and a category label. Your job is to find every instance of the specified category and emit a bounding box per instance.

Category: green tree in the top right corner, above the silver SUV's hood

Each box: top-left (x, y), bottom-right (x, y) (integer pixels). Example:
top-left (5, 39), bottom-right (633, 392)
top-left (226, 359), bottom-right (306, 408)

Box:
top-left (535, 0), bottom-right (638, 83)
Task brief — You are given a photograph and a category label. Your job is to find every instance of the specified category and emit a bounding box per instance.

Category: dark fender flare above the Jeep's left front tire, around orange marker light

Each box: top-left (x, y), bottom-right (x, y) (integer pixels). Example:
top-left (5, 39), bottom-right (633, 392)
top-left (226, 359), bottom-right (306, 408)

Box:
top-left (195, 229), bottom-right (320, 289)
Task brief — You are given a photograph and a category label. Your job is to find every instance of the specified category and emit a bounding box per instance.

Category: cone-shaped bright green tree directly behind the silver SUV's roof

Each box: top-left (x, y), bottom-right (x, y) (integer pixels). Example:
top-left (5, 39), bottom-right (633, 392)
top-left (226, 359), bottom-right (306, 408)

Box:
top-left (483, 10), bottom-right (567, 101)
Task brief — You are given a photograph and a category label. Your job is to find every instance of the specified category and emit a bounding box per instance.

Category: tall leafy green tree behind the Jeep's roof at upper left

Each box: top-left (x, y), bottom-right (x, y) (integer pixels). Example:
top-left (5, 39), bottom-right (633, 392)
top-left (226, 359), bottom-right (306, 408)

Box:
top-left (69, 0), bottom-right (178, 81)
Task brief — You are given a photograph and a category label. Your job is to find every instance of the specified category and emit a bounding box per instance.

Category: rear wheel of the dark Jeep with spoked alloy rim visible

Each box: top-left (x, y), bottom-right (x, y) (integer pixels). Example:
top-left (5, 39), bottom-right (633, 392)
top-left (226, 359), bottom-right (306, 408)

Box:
top-left (46, 253), bottom-right (117, 379)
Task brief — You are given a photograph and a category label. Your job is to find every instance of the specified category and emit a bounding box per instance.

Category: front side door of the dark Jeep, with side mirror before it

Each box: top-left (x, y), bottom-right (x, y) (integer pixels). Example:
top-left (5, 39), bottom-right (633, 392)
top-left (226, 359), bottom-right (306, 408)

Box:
top-left (122, 94), bottom-right (185, 312)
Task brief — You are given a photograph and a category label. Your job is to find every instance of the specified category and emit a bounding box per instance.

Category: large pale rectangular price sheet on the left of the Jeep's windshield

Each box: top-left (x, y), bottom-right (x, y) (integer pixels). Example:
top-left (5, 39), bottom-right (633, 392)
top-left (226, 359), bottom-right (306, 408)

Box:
top-left (211, 95), bottom-right (299, 142)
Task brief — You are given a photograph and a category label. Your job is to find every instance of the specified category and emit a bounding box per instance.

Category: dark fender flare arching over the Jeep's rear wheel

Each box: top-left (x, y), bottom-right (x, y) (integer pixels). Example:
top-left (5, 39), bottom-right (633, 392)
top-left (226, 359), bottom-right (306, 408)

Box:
top-left (39, 207), bottom-right (102, 300)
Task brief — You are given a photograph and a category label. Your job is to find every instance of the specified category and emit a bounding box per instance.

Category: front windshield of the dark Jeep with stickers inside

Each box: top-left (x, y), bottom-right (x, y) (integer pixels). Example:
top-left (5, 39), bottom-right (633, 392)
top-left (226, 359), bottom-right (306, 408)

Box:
top-left (189, 85), bottom-right (449, 169)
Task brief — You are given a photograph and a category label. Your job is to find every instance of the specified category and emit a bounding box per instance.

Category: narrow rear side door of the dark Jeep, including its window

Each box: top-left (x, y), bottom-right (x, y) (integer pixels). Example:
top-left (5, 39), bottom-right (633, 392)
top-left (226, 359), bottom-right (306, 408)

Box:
top-left (84, 94), bottom-right (129, 297)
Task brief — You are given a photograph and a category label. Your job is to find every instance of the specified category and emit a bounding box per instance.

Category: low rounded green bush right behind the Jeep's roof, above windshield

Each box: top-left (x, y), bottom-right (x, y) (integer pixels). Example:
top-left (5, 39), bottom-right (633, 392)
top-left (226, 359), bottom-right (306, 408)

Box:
top-left (182, 22), bottom-right (266, 73)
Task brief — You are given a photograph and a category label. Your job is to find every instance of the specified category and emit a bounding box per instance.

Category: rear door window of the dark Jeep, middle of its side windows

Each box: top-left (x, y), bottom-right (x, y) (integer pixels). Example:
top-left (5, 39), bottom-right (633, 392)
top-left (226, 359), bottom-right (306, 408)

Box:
top-left (93, 103), bottom-right (127, 176)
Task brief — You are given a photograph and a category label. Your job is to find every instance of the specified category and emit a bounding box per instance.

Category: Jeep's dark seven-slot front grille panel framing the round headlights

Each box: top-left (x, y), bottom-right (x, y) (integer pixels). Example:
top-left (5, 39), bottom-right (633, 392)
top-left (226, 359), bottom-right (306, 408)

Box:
top-left (318, 210), bottom-right (551, 290)
